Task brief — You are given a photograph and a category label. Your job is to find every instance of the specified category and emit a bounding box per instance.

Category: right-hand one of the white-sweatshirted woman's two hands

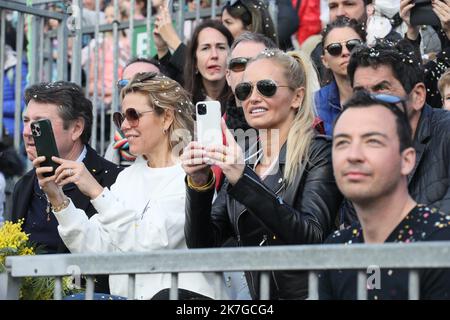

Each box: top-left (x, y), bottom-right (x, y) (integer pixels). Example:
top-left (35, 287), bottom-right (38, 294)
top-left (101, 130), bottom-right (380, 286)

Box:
top-left (52, 157), bottom-right (103, 199)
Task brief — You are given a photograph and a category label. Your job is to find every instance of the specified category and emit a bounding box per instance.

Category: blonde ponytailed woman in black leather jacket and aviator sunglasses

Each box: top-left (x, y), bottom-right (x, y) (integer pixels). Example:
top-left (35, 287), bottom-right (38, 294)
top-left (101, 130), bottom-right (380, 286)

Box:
top-left (182, 49), bottom-right (342, 299)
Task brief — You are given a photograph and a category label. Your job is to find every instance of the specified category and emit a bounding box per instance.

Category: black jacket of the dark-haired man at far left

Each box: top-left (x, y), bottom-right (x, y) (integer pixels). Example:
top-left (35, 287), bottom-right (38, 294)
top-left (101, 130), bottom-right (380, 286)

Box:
top-left (11, 145), bottom-right (122, 293)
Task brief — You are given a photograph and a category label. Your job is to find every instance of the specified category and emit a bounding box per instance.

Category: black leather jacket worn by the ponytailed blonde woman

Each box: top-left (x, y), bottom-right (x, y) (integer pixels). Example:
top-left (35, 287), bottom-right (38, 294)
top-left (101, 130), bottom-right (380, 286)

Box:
top-left (185, 136), bottom-right (342, 299)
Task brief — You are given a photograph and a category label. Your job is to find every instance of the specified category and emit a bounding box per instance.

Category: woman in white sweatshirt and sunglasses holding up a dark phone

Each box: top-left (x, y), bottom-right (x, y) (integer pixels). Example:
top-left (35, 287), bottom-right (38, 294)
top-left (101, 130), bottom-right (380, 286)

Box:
top-left (33, 73), bottom-right (222, 299)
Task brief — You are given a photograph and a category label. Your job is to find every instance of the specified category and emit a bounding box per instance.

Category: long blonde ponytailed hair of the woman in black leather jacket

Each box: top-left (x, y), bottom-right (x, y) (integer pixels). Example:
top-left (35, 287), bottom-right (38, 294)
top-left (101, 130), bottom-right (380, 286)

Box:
top-left (250, 49), bottom-right (318, 185)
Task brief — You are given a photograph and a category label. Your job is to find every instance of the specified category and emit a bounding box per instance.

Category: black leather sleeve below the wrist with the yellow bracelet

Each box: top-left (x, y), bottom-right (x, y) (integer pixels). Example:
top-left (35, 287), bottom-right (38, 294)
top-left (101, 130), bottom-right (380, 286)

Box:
top-left (184, 179), bottom-right (232, 248)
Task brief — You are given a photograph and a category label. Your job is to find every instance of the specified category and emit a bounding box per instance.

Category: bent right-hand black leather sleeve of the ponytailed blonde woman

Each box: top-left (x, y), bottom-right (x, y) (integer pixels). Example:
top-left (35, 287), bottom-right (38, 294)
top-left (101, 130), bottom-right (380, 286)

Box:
top-left (228, 139), bottom-right (342, 244)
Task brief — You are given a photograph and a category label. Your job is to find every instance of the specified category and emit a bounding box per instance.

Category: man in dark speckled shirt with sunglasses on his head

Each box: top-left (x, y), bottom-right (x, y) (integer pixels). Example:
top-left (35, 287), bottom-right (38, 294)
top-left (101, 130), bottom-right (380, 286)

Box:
top-left (319, 91), bottom-right (450, 300)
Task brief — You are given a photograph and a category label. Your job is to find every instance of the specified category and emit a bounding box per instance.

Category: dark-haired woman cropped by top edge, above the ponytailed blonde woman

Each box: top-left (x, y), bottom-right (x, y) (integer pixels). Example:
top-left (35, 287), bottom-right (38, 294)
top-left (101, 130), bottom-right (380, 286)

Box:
top-left (222, 0), bottom-right (278, 44)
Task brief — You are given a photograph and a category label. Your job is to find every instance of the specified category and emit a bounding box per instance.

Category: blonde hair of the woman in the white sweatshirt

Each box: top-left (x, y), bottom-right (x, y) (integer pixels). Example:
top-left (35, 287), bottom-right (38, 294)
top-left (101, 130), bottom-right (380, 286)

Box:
top-left (120, 72), bottom-right (194, 150)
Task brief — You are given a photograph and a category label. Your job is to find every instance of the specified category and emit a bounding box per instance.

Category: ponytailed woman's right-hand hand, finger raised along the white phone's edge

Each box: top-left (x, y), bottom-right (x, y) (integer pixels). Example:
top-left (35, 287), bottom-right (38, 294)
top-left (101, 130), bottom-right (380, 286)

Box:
top-left (206, 119), bottom-right (245, 185)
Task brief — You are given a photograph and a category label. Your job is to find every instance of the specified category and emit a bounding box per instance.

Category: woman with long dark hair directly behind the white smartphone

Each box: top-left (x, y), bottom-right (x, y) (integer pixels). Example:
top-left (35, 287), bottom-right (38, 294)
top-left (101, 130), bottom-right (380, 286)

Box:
top-left (184, 20), bottom-right (233, 113)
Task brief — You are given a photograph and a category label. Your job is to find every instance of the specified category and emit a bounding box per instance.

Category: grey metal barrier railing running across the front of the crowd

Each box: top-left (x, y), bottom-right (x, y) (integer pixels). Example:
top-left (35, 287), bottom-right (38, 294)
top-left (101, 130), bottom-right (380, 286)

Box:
top-left (0, 242), bottom-right (450, 300)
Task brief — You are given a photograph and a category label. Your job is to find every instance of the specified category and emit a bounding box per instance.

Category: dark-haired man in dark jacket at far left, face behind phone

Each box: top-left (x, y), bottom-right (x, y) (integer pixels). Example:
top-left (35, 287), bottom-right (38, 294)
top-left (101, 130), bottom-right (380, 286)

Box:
top-left (11, 81), bottom-right (120, 292)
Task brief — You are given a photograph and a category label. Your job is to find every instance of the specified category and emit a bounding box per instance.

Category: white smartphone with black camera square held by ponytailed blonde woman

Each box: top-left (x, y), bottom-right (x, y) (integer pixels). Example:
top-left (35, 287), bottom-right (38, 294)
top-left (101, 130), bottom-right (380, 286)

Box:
top-left (195, 101), bottom-right (223, 146)
